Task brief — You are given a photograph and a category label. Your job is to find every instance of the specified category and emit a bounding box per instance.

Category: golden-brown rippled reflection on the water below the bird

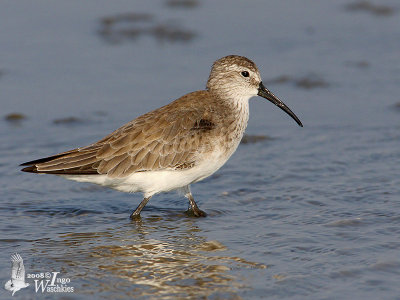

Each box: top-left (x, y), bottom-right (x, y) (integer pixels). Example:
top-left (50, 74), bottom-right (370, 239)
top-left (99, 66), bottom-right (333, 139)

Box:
top-left (21, 214), bottom-right (267, 299)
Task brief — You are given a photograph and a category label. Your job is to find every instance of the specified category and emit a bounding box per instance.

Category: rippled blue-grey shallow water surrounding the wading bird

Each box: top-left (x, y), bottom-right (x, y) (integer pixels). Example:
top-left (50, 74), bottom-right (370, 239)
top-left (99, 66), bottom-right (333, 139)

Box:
top-left (0, 0), bottom-right (400, 299)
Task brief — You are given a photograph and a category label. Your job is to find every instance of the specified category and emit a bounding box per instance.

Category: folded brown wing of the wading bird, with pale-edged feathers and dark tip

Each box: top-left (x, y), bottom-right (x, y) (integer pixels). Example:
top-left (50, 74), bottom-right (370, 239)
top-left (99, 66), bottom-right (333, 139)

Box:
top-left (23, 91), bottom-right (222, 177)
